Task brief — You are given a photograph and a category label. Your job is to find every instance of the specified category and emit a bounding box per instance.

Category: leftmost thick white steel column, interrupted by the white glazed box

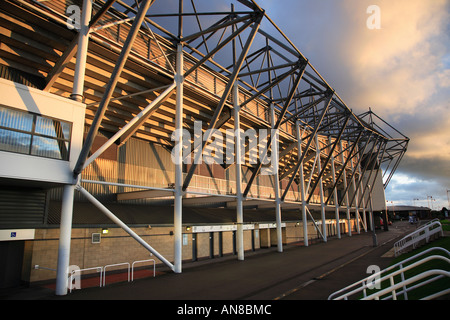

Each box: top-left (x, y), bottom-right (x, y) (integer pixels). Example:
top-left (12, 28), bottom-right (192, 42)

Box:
top-left (55, 0), bottom-right (92, 296)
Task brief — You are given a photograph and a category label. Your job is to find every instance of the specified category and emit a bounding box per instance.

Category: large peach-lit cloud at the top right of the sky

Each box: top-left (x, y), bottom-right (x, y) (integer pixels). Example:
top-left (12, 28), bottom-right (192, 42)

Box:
top-left (334, 0), bottom-right (450, 116)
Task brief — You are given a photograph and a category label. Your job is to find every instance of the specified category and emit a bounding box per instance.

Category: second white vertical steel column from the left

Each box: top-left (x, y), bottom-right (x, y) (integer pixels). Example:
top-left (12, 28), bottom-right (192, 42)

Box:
top-left (173, 43), bottom-right (184, 273)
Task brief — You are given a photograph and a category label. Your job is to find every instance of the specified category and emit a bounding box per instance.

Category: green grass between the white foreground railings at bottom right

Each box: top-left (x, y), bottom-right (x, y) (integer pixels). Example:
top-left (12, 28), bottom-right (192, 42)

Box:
top-left (367, 237), bottom-right (450, 300)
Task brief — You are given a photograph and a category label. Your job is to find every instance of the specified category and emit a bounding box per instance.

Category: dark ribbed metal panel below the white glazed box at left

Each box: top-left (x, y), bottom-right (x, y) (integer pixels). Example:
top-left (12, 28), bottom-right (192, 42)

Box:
top-left (0, 187), bottom-right (46, 229)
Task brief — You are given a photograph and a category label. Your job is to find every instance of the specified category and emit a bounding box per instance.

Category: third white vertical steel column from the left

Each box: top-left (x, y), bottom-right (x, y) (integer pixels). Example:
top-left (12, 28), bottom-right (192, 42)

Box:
top-left (233, 82), bottom-right (244, 260)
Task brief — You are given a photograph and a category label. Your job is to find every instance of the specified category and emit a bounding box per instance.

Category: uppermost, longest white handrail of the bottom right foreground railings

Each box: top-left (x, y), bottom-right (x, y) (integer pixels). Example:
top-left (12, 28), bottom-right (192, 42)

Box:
top-left (328, 247), bottom-right (450, 300)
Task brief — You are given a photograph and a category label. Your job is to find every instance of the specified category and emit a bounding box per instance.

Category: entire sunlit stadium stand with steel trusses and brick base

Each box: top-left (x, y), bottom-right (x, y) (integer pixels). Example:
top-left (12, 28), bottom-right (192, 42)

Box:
top-left (0, 0), bottom-right (409, 295)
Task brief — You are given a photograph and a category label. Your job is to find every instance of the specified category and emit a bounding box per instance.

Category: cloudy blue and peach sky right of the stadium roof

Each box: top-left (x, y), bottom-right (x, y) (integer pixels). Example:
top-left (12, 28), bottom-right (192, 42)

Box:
top-left (250, 0), bottom-right (450, 209)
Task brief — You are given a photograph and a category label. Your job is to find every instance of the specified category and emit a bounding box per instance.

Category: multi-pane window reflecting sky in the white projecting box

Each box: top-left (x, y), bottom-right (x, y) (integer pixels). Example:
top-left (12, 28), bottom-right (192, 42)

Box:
top-left (0, 106), bottom-right (72, 160)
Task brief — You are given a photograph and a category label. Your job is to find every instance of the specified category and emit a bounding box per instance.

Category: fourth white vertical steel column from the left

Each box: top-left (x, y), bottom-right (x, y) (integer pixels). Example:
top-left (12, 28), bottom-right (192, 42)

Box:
top-left (267, 103), bottom-right (283, 252)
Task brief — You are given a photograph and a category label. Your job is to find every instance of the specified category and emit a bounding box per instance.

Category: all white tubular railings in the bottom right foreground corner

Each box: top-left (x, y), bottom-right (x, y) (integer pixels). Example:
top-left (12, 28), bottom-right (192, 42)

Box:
top-left (328, 247), bottom-right (450, 300)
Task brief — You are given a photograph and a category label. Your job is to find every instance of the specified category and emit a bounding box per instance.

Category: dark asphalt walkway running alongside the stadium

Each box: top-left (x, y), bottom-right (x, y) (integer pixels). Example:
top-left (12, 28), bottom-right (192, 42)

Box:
top-left (0, 222), bottom-right (415, 300)
